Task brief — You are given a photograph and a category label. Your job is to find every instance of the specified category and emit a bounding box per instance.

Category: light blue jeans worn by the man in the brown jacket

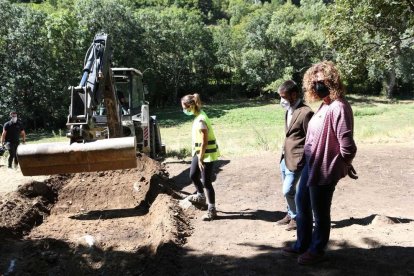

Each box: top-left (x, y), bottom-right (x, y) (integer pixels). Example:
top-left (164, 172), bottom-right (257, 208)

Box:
top-left (280, 158), bottom-right (301, 219)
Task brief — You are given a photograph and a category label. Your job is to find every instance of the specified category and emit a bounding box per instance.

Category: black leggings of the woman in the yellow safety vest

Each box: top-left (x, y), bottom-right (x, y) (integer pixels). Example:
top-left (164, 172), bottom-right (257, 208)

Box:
top-left (190, 154), bottom-right (216, 204)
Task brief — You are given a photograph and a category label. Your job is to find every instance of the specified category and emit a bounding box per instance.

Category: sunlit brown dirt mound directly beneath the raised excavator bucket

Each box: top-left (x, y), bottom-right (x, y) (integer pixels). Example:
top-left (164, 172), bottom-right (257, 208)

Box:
top-left (52, 156), bottom-right (163, 215)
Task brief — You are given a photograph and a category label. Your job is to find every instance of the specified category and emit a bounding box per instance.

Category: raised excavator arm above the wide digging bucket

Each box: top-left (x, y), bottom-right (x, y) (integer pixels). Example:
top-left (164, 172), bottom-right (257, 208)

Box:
top-left (67, 34), bottom-right (121, 143)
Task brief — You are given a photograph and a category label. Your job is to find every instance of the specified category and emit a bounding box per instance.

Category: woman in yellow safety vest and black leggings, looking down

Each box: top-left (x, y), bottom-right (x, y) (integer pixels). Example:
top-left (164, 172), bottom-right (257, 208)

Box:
top-left (181, 93), bottom-right (220, 221)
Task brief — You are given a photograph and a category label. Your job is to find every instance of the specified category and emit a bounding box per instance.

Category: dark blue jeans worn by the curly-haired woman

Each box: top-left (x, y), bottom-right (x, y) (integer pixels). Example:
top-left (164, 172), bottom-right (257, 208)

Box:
top-left (293, 164), bottom-right (337, 254)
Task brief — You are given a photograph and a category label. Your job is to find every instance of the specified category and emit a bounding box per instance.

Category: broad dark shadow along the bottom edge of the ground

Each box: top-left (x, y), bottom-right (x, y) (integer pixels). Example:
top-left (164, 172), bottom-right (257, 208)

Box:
top-left (0, 235), bottom-right (414, 275)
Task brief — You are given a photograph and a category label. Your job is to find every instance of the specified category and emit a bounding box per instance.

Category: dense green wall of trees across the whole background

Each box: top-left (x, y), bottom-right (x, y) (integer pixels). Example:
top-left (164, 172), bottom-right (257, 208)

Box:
top-left (0, 0), bottom-right (414, 129)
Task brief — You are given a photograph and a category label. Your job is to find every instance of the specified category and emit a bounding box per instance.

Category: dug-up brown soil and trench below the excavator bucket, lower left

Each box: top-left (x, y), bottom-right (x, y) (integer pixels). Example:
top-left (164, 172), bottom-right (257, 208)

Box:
top-left (0, 156), bottom-right (188, 275)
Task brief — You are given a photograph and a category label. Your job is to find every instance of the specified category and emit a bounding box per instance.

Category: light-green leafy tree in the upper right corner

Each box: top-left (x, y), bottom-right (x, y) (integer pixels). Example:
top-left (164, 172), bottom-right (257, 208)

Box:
top-left (324, 0), bottom-right (414, 97)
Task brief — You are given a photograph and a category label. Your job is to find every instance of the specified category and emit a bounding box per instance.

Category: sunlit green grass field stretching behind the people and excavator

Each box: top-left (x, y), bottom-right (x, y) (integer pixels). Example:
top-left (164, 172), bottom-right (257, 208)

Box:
top-left (28, 95), bottom-right (414, 158)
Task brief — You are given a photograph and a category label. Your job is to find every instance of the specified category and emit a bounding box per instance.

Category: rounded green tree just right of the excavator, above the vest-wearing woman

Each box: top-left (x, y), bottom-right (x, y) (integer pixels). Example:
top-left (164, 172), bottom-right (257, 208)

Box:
top-left (136, 7), bottom-right (212, 104)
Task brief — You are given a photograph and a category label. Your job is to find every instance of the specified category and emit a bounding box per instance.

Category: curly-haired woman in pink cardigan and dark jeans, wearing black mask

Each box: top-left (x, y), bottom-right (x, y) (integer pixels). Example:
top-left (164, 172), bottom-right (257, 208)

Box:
top-left (282, 61), bottom-right (357, 265)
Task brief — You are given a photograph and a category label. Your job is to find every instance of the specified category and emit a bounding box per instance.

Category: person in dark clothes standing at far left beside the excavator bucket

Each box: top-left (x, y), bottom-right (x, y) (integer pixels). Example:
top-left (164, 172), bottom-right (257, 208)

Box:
top-left (1, 111), bottom-right (26, 169)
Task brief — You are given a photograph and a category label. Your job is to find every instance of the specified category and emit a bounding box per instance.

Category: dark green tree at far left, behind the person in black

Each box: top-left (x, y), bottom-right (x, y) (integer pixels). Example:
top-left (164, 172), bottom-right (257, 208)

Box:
top-left (2, 6), bottom-right (53, 128)
